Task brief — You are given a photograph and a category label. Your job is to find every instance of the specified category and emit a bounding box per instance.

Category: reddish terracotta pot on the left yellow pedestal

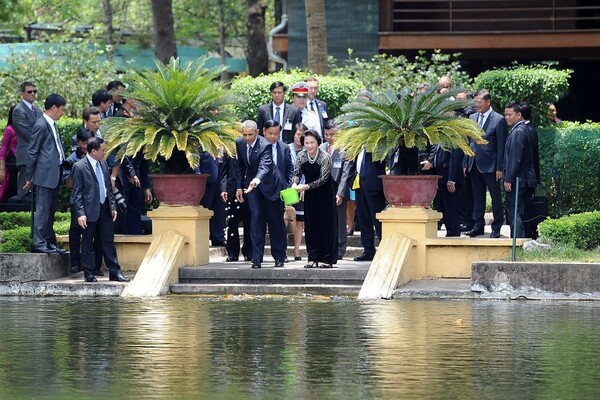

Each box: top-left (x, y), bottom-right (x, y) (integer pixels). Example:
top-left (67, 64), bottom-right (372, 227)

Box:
top-left (151, 174), bottom-right (210, 206)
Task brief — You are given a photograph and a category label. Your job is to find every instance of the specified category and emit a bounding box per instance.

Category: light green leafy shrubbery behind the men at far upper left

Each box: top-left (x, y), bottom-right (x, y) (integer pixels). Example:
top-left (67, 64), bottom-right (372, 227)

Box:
top-left (0, 39), bottom-right (117, 120)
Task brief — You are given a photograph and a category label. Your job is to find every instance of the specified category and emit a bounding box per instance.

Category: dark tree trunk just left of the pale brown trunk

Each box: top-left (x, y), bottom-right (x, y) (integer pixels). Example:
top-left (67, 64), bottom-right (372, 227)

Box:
top-left (246, 0), bottom-right (269, 76)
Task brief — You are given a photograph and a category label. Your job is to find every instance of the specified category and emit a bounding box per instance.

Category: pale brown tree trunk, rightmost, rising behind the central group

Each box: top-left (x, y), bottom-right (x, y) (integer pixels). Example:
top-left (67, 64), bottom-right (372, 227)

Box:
top-left (305, 0), bottom-right (328, 75)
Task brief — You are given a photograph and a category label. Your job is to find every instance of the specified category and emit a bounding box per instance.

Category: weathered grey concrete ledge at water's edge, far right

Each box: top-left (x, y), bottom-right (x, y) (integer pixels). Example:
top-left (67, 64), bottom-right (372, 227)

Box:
top-left (471, 261), bottom-right (600, 300)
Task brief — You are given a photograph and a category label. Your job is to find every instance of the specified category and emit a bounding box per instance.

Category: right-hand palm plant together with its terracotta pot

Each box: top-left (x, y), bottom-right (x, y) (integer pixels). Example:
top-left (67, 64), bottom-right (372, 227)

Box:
top-left (334, 87), bottom-right (486, 207)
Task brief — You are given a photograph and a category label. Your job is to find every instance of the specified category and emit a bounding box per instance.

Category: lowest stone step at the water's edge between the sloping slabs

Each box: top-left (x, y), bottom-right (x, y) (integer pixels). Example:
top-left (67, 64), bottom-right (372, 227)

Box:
top-left (170, 283), bottom-right (361, 297)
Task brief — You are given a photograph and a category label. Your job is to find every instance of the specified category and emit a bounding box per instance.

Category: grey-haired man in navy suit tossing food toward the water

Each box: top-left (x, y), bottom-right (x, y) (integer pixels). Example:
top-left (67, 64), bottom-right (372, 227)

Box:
top-left (235, 120), bottom-right (283, 268)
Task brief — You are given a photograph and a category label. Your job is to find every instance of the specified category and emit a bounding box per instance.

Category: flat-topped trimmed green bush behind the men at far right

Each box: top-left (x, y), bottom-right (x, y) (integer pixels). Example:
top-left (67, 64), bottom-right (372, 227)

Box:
top-left (474, 65), bottom-right (573, 126)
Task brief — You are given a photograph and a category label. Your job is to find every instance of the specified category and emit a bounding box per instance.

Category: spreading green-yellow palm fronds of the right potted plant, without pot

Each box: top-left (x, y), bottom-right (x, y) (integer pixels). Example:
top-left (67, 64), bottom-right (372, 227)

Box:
top-left (335, 87), bottom-right (486, 161)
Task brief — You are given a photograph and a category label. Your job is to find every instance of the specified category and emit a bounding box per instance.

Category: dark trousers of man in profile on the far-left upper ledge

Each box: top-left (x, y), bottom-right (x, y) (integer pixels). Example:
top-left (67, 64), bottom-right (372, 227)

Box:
top-left (32, 185), bottom-right (58, 250)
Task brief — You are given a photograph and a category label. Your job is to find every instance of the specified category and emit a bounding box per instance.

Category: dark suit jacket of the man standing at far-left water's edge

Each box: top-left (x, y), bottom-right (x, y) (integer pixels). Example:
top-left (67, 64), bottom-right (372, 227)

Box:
top-left (71, 157), bottom-right (117, 222)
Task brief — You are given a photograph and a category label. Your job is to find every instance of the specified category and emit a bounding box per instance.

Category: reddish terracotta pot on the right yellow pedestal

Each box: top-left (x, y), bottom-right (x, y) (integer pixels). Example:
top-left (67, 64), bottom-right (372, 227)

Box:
top-left (379, 175), bottom-right (440, 208)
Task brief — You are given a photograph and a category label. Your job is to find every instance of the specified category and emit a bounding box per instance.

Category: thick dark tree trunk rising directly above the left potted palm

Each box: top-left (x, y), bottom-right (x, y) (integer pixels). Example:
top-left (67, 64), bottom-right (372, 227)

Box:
top-left (152, 0), bottom-right (177, 64)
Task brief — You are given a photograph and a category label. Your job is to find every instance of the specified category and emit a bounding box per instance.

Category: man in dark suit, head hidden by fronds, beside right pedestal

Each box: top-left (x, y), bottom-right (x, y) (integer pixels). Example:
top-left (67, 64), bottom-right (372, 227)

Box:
top-left (354, 149), bottom-right (385, 261)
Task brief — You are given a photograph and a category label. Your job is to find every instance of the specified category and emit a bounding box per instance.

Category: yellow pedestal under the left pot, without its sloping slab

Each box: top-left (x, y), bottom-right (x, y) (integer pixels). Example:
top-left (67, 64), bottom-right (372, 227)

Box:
top-left (148, 205), bottom-right (213, 267)
